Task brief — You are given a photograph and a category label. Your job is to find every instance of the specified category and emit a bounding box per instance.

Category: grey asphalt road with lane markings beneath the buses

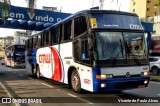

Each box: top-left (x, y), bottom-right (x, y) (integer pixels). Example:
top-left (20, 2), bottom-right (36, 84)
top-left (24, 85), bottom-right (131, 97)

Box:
top-left (0, 65), bottom-right (160, 106)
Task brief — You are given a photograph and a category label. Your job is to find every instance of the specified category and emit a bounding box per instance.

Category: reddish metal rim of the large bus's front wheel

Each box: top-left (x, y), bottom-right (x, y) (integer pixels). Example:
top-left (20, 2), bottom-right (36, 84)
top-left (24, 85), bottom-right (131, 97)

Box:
top-left (72, 72), bottom-right (80, 91)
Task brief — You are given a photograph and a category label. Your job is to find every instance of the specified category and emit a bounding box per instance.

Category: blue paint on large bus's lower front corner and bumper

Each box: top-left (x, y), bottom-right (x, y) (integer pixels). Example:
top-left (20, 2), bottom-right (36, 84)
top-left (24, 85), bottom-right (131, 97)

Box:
top-left (92, 68), bottom-right (150, 92)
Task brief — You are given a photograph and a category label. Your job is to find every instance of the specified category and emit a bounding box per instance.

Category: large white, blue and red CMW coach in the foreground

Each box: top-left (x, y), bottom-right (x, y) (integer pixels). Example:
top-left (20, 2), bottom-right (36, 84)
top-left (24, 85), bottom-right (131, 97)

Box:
top-left (25, 10), bottom-right (150, 93)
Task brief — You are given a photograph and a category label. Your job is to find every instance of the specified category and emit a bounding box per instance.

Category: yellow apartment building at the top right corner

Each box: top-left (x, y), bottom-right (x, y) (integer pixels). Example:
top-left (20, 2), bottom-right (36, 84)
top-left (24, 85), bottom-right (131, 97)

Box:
top-left (130, 0), bottom-right (159, 18)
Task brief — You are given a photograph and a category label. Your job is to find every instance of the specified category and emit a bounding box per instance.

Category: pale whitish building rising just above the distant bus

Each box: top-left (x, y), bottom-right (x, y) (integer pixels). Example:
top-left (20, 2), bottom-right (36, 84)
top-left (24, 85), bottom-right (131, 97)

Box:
top-left (14, 31), bottom-right (31, 44)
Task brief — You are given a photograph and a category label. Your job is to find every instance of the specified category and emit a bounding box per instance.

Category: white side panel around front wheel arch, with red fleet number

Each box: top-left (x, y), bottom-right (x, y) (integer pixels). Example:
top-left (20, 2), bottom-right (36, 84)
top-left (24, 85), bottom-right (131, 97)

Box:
top-left (60, 42), bottom-right (93, 91)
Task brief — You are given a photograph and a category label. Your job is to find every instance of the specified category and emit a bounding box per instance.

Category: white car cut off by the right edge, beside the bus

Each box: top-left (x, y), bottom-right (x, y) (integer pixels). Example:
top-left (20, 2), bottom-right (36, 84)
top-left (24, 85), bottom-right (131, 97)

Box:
top-left (149, 56), bottom-right (160, 75)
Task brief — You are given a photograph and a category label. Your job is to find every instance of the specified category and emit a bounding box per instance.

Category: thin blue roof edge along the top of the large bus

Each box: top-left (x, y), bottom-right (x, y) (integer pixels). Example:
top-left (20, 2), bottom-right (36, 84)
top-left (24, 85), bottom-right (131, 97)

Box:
top-left (28, 10), bottom-right (138, 39)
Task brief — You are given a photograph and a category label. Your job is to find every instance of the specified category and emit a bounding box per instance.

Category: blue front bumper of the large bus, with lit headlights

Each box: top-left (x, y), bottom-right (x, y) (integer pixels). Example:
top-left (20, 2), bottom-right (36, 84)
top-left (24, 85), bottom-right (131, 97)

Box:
top-left (93, 77), bottom-right (150, 92)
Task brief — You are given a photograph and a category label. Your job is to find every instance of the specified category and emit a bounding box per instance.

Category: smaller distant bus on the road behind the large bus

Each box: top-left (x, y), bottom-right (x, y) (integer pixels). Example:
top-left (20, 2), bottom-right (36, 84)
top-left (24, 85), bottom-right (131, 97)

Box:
top-left (5, 44), bottom-right (25, 68)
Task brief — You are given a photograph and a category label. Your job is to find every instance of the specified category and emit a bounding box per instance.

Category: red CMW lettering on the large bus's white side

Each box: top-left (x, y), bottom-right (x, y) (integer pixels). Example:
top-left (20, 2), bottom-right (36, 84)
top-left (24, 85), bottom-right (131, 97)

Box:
top-left (39, 54), bottom-right (51, 63)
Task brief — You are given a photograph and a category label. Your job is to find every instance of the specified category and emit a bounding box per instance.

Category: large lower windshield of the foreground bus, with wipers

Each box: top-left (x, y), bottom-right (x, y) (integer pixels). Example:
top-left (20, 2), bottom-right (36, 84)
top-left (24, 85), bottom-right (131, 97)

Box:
top-left (95, 32), bottom-right (147, 60)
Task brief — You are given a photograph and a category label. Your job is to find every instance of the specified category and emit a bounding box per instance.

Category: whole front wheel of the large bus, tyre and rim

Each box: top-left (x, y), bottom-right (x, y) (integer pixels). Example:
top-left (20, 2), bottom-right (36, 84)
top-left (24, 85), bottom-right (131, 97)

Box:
top-left (71, 70), bottom-right (81, 93)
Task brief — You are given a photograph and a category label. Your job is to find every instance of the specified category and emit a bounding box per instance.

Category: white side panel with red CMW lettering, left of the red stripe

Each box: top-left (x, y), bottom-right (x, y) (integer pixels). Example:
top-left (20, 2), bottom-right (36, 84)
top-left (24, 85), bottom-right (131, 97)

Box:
top-left (36, 47), bottom-right (53, 79)
